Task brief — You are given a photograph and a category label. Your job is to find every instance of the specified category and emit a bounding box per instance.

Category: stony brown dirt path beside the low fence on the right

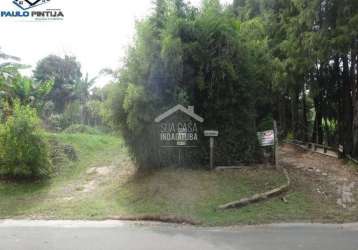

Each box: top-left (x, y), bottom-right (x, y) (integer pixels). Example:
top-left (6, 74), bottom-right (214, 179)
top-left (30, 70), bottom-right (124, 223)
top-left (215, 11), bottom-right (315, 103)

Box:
top-left (279, 144), bottom-right (358, 210)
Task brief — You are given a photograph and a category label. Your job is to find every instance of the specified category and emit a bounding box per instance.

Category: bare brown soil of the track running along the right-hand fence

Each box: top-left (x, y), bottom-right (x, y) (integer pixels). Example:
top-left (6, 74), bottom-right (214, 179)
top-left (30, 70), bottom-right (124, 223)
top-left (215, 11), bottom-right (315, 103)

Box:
top-left (279, 144), bottom-right (358, 213)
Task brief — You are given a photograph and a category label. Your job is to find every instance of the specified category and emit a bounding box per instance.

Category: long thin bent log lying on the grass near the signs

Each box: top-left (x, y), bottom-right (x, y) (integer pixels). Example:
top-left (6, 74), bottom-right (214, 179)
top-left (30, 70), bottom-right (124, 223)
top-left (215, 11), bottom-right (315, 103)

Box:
top-left (218, 168), bottom-right (291, 209)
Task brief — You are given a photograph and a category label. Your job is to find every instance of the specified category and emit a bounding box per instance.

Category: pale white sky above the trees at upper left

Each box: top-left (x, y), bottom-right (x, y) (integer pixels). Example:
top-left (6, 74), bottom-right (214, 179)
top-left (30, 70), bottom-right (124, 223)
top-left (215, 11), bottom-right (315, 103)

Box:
top-left (0, 0), bottom-right (231, 86)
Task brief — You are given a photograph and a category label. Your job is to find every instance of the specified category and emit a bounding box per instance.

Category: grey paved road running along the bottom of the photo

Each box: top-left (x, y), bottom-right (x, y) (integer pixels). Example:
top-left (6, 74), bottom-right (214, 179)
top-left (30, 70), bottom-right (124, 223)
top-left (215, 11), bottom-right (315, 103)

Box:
top-left (0, 220), bottom-right (358, 250)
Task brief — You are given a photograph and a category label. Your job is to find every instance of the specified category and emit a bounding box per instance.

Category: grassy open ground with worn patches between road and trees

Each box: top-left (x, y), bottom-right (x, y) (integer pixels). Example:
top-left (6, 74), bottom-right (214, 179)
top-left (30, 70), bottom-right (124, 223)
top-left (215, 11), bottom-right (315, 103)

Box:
top-left (0, 134), bottom-right (358, 225)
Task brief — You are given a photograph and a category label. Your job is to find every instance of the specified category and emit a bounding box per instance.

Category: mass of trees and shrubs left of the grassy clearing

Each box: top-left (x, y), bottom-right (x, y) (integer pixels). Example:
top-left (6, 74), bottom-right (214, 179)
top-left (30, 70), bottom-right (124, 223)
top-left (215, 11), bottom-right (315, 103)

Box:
top-left (0, 51), bottom-right (103, 178)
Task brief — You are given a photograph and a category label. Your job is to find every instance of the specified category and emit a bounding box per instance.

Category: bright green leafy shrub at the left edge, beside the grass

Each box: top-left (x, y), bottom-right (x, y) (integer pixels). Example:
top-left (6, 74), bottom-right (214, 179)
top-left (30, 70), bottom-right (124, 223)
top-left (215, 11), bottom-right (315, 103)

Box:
top-left (0, 103), bottom-right (51, 178)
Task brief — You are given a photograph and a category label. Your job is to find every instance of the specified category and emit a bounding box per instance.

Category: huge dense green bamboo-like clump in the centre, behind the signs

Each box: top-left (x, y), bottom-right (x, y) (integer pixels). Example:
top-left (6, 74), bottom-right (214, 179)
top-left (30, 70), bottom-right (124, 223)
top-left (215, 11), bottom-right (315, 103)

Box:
top-left (109, 0), bottom-right (268, 168)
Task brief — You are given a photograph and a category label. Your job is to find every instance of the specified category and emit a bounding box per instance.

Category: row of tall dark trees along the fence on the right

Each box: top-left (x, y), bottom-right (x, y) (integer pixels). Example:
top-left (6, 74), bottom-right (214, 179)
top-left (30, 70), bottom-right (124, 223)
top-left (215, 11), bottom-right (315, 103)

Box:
top-left (243, 0), bottom-right (358, 154)
